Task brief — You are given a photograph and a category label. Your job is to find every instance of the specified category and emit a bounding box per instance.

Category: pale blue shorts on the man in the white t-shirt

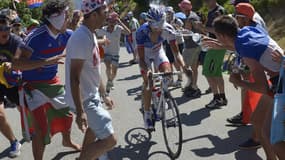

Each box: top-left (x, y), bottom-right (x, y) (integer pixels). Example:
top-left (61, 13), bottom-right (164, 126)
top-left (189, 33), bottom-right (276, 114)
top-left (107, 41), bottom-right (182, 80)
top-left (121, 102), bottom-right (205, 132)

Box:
top-left (83, 93), bottom-right (114, 140)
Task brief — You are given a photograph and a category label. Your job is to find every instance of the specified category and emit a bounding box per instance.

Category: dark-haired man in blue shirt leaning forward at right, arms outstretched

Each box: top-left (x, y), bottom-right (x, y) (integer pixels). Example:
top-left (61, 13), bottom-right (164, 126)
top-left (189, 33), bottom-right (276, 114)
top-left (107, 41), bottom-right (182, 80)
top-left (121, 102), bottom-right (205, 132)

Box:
top-left (208, 14), bottom-right (285, 159)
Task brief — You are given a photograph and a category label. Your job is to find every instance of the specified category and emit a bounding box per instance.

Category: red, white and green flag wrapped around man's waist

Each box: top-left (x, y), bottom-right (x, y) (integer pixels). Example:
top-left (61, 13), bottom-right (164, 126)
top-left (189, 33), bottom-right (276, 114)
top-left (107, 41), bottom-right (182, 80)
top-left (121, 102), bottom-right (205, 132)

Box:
top-left (19, 80), bottom-right (72, 144)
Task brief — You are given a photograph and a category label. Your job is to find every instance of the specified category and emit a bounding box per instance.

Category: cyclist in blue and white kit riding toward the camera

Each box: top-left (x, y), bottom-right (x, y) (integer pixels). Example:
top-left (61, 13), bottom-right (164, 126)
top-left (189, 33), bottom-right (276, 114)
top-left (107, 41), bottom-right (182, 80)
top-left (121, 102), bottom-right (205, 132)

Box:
top-left (136, 8), bottom-right (192, 130)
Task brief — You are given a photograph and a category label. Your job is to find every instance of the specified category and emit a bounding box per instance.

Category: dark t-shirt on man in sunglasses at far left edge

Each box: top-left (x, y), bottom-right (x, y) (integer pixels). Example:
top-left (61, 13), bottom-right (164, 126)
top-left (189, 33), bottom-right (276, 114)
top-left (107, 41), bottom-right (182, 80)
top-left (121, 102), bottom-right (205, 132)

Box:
top-left (0, 33), bottom-right (31, 64)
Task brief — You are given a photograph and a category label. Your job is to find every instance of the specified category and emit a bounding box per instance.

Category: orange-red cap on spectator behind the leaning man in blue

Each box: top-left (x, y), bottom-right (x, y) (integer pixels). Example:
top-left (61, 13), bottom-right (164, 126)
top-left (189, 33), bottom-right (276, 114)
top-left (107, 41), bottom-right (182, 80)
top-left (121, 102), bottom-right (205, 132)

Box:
top-left (235, 3), bottom-right (255, 20)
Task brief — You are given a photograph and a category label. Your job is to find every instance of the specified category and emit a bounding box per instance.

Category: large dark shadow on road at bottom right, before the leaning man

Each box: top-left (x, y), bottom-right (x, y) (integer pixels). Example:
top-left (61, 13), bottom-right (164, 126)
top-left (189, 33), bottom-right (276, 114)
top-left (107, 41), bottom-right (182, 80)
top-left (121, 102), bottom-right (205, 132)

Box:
top-left (180, 126), bottom-right (262, 160)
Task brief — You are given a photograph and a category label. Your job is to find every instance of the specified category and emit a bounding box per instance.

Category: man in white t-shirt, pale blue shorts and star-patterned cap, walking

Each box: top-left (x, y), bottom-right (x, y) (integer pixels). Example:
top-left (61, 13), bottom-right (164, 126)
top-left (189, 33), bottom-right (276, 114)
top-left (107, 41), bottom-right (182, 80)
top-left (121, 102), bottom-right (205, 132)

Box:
top-left (65, 0), bottom-right (116, 160)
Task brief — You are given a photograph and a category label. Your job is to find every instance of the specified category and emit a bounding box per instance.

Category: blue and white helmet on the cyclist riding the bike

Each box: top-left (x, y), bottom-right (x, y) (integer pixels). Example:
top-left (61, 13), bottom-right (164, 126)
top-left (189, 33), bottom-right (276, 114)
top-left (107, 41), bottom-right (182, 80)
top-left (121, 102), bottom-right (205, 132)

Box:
top-left (147, 7), bottom-right (166, 28)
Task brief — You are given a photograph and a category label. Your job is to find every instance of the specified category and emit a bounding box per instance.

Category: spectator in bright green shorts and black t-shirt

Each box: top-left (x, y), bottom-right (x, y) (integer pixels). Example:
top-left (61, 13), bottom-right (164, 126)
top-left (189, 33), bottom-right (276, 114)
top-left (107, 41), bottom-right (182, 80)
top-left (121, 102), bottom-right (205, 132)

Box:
top-left (201, 0), bottom-right (228, 109)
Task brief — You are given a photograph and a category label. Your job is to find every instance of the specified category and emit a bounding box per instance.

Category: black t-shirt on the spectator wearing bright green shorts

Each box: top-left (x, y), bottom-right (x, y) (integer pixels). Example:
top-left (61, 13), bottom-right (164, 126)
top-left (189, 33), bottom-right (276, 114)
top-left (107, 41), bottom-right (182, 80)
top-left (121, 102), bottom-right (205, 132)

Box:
top-left (206, 5), bottom-right (226, 38)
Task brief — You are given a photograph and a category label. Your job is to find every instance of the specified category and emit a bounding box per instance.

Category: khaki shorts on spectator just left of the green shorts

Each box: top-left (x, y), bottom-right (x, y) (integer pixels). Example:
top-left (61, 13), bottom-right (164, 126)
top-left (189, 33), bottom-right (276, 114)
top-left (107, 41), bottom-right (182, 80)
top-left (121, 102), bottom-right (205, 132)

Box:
top-left (182, 47), bottom-right (201, 66)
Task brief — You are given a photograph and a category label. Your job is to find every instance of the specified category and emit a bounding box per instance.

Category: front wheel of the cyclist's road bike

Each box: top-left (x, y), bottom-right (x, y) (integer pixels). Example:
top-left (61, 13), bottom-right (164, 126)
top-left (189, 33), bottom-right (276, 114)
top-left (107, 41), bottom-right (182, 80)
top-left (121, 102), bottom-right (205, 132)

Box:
top-left (161, 96), bottom-right (182, 159)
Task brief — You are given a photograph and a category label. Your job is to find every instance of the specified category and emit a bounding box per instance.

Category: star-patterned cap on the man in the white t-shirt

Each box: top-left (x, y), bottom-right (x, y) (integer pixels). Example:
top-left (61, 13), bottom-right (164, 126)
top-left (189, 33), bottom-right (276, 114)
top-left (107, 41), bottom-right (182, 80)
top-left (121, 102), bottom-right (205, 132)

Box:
top-left (81, 0), bottom-right (107, 15)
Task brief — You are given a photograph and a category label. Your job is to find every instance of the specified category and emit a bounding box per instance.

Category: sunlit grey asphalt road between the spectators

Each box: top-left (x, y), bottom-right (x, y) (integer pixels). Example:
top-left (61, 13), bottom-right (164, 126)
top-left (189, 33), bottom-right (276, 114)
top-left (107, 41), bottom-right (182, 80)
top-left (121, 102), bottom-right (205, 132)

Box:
top-left (0, 48), bottom-right (265, 160)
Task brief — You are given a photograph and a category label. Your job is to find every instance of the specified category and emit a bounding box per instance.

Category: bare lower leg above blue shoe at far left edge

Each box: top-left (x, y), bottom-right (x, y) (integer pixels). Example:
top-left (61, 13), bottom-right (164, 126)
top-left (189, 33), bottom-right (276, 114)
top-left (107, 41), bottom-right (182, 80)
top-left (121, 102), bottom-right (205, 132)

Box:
top-left (0, 102), bottom-right (16, 142)
